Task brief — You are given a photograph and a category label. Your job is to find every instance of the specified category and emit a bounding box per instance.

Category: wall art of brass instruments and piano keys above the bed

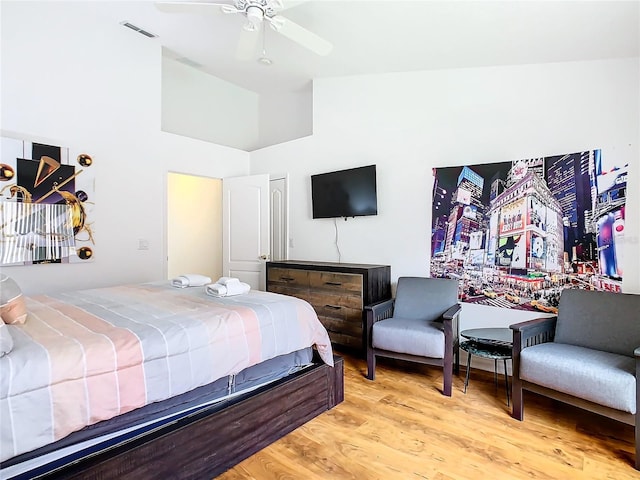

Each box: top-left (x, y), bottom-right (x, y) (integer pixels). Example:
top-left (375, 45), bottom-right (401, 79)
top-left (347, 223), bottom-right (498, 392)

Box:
top-left (0, 137), bottom-right (95, 266)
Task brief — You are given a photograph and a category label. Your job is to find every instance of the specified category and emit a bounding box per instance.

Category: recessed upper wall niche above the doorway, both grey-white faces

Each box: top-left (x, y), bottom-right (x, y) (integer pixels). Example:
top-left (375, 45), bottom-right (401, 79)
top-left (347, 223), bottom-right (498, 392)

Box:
top-left (162, 49), bottom-right (313, 151)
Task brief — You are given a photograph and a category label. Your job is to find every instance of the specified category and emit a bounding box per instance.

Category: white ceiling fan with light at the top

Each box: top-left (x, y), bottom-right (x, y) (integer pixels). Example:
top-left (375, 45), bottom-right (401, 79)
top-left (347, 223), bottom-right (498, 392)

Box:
top-left (156, 0), bottom-right (333, 59)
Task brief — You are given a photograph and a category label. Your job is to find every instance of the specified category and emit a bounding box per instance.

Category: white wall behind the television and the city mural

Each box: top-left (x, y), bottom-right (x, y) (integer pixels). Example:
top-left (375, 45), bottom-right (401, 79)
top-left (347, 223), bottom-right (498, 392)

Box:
top-left (251, 58), bottom-right (640, 328)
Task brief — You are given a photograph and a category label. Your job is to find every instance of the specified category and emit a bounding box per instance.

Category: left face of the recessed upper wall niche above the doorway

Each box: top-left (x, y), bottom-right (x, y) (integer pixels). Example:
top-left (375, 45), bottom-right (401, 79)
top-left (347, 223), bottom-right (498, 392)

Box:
top-left (162, 55), bottom-right (260, 151)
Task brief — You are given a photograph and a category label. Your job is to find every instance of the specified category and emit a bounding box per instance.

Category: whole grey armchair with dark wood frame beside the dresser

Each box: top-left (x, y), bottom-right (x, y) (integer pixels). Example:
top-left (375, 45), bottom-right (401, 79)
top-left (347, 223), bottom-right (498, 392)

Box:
top-left (365, 277), bottom-right (461, 397)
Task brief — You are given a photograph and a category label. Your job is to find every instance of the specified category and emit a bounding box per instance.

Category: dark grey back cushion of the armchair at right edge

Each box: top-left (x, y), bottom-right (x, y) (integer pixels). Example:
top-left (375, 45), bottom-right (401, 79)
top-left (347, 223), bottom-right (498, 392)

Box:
top-left (555, 290), bottom-right (640, 357)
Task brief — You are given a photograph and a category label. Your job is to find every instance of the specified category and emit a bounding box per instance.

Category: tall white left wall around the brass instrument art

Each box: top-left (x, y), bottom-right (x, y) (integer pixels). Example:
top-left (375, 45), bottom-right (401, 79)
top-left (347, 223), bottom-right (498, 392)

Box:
top-left (0, 1), bottom-right (249, 294)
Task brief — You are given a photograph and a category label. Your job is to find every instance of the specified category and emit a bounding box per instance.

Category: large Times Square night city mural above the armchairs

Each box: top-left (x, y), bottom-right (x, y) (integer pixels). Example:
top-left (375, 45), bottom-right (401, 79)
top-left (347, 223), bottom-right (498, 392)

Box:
top-left (430, 150), bottom-right (628, 313)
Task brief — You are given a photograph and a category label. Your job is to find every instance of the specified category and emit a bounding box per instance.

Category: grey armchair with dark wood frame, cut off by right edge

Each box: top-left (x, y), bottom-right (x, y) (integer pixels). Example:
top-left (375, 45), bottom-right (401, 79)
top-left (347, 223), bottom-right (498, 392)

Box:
top-left (511, 290), bottom-right (640, 469)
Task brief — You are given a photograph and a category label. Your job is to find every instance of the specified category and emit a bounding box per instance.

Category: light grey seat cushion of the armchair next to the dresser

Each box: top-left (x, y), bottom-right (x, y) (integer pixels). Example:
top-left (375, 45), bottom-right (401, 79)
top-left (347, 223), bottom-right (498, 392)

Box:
top-left (372, 317), bottom-right (444, 358)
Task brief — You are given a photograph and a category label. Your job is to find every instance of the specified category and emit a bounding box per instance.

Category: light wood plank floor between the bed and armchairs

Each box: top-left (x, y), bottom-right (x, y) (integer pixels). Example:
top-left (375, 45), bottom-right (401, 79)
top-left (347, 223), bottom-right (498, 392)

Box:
top-left (218, 354), bottom-right (640, 480)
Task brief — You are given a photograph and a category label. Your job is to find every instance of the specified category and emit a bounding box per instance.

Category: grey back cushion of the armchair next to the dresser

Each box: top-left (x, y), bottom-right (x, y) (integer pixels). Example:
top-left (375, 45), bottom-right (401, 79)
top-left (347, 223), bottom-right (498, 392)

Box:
top-left (393, 277), bottom-right (458, 320)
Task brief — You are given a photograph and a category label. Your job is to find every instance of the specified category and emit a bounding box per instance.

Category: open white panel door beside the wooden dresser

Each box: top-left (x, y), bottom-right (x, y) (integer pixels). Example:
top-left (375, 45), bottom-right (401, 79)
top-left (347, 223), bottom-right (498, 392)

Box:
top-left (222, 175), bottom-right (269, 290)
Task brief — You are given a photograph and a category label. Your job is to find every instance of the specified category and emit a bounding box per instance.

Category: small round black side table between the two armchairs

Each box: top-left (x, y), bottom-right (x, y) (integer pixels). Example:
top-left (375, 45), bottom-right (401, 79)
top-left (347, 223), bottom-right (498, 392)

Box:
top-left (460, 328), bottom-right (513, 406)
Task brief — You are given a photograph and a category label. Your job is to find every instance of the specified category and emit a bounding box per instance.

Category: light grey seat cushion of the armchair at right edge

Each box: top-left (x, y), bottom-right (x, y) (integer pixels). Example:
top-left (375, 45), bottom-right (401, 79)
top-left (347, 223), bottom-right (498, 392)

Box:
top-left (520, 342), bottom-right (636, 414)
